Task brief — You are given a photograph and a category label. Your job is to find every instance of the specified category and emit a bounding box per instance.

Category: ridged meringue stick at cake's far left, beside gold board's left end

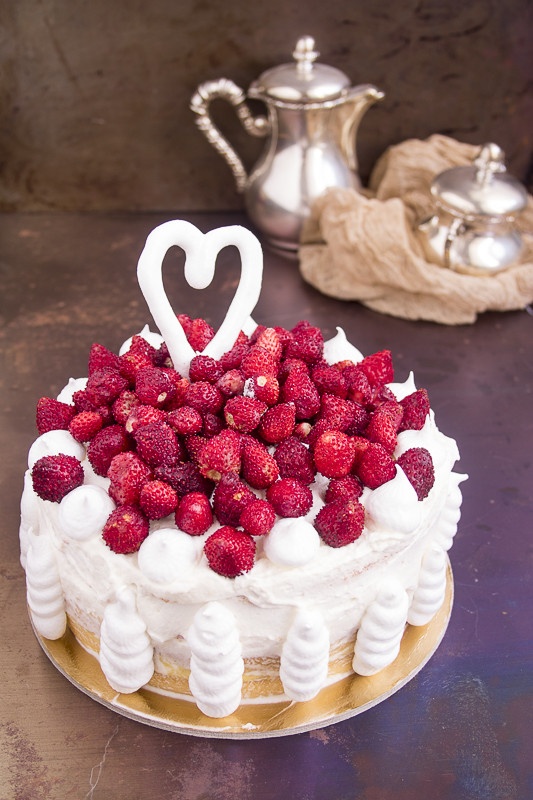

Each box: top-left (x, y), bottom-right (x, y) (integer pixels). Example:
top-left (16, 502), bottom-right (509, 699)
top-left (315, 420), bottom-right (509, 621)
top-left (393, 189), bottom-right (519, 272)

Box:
top-left (26, 536), bottom-right (67, 639)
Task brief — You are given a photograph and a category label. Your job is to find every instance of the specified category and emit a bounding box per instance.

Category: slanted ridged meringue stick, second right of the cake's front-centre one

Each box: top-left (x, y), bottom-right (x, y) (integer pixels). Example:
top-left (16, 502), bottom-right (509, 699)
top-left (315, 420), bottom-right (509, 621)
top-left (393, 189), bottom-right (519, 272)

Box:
top-left (352, 579), bottom-right (409, 675)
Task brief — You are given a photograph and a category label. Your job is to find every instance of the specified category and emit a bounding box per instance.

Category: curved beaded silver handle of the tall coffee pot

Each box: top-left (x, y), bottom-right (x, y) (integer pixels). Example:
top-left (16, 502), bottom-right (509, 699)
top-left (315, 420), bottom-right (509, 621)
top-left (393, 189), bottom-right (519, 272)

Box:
top-left (190, 78), bottom-right (270, 192)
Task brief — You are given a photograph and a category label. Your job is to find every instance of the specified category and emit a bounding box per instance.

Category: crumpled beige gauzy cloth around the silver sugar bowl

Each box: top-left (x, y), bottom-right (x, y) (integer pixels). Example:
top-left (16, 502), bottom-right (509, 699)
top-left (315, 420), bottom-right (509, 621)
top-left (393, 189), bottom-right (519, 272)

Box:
top-left (299, 135), bottom-right (533, 325)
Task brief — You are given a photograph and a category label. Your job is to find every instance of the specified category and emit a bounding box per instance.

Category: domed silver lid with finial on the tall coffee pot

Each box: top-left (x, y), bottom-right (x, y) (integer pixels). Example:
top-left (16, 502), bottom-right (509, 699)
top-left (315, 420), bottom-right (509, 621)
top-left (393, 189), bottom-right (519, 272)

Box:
top-left (248, 36), bottom-right (350, 105)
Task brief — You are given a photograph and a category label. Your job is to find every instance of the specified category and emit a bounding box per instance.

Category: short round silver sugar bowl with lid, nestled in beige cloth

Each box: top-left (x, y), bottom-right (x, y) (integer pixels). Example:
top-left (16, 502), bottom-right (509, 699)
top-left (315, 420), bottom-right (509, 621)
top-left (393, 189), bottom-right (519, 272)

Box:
top-left (418, 143), bottom-right (527, 275)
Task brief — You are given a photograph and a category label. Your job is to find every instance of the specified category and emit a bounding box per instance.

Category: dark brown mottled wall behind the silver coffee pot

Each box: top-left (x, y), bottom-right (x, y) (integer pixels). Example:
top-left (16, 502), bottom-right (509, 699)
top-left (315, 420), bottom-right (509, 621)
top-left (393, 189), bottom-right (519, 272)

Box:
top-left (0, 0), bottom-right (533, 211)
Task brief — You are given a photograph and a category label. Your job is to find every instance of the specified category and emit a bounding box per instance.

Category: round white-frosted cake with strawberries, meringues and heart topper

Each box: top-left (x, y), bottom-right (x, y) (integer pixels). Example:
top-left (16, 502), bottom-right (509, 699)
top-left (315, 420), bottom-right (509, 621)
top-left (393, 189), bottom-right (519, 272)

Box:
top-left (20, 221), bottom-right (466, 718)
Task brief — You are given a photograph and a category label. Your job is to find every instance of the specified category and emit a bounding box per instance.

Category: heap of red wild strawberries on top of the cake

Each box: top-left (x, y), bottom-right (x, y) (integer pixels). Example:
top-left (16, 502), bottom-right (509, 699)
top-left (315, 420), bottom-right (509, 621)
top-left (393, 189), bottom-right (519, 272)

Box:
top-left (32, 315), bottom-right (434, 577)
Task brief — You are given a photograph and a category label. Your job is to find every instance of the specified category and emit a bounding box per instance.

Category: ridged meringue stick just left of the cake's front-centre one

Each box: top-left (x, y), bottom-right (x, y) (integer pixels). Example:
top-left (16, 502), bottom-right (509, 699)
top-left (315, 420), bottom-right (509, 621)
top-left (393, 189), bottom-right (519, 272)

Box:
top-left (99, 586), bottom-right (154, 694)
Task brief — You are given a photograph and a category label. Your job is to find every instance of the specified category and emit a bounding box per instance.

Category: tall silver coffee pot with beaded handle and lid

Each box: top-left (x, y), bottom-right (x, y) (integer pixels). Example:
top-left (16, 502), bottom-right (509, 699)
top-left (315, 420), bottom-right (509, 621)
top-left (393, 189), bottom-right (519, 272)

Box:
top-left (191, 36), bottom-right (384, 252)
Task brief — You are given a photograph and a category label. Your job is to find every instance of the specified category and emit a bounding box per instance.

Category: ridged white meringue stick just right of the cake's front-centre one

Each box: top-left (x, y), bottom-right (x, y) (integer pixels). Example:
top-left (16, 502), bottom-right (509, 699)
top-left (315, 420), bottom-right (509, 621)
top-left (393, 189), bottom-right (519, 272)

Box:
top-left (279, 608), bottom-right (329, 702)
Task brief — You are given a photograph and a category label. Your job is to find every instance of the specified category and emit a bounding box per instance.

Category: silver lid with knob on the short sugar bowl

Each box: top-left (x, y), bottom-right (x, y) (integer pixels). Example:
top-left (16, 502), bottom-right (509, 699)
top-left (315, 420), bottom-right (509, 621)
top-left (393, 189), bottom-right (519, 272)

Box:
top-left (431, 143), bottom-right (527, 217)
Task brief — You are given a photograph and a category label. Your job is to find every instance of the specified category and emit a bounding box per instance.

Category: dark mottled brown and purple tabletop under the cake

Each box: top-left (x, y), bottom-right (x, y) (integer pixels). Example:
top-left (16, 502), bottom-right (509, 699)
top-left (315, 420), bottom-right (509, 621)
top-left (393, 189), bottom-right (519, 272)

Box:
top-left (0, 213), bottom-right (533, 800)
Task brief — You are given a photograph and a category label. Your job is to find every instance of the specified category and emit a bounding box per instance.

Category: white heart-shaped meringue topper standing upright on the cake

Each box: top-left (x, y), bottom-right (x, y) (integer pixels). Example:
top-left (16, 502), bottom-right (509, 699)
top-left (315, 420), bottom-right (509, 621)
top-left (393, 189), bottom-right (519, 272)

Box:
top-left (137, 220), bottom-right (263, 376)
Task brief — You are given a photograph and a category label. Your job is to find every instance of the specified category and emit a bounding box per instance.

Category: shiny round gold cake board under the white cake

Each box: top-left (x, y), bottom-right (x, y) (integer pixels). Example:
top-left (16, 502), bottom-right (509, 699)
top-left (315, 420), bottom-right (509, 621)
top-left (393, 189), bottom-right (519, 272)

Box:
top-left (34, 563), bottom-right (453, 739)
